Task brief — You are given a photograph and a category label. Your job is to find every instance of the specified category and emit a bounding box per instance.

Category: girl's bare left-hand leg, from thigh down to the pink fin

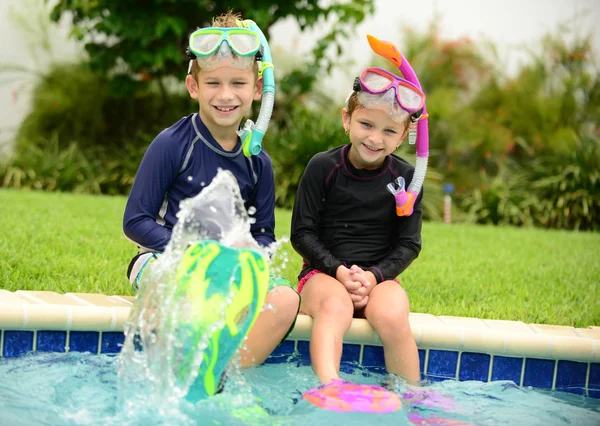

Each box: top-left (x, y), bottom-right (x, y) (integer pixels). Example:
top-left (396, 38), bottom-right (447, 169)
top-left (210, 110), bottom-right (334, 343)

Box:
top-left (300, 273), bottom-right (354, 384)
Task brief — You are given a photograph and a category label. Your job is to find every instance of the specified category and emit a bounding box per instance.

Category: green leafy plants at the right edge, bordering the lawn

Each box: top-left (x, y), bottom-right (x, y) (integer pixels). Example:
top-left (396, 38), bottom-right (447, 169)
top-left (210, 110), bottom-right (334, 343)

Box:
top-left (460, 138), bottom-right (600, 231)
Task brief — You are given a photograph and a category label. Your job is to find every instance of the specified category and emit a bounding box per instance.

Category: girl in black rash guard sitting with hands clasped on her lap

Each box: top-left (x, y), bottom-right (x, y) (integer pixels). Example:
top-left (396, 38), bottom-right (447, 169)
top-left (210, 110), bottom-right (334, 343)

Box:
top-left (291, 55), bottom-right (425, 384)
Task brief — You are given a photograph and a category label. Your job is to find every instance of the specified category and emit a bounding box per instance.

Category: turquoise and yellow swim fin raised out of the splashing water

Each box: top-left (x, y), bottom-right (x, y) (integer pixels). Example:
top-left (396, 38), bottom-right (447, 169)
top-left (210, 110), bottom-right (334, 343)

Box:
top-left (175, 240), bottom-right (269, 401)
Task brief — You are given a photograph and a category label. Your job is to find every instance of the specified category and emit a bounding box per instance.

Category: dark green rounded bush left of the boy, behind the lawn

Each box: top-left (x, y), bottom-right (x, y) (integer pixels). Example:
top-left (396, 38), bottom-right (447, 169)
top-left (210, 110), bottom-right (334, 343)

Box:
top-left (16, 62), bottom-right (192, 150)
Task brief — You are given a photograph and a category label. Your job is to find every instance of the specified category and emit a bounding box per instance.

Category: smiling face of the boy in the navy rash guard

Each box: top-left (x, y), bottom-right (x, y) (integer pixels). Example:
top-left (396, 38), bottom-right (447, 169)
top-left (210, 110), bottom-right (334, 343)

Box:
top-left (186, 61), bottom-right (262, 131)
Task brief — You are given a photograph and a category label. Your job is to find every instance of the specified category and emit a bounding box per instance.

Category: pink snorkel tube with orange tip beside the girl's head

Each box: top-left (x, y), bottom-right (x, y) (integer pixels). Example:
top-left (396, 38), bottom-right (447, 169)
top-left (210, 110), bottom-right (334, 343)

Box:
top-left (367, 34), bottom-right (429, 216)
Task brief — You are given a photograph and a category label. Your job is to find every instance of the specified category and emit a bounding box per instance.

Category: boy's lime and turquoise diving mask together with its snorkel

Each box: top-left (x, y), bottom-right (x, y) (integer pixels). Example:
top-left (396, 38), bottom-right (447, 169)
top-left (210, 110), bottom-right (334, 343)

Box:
top-left (188, 19), bottom-right (275, 157)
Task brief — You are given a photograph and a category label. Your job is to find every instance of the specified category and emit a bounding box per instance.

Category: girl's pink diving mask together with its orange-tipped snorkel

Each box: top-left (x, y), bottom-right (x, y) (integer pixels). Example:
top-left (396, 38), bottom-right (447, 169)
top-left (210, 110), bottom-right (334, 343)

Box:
top-left (354, 34), bottom-right (429, 216)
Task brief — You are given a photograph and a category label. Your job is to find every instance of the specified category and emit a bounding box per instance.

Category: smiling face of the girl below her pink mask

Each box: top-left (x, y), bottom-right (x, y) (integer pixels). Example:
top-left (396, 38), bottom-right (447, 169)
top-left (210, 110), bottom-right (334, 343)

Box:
top-left (342, 108), bottom-right (408, 169)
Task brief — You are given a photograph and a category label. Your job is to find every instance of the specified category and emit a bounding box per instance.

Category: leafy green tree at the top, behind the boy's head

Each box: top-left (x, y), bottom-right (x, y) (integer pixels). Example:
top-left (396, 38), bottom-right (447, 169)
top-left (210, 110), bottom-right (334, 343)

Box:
top-left (47, 0), bottom-right (374, 94)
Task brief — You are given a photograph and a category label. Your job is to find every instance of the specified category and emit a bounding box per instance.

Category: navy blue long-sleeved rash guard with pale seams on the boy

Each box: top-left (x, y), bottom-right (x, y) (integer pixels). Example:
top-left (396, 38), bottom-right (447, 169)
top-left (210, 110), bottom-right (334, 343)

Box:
top-left (123, 114), bottom-right (275, 252)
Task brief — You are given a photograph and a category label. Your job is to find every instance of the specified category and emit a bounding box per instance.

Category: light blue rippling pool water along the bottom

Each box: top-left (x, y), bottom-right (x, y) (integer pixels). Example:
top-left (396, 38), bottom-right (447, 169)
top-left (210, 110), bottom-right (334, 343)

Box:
top-left (0, 353), bottom-right (600, 426)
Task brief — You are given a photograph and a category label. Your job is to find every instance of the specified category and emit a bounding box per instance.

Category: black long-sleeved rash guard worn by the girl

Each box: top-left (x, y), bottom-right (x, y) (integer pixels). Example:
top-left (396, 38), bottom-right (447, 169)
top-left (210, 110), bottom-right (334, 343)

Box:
top-left (291, 145), bottom-right (423, 283)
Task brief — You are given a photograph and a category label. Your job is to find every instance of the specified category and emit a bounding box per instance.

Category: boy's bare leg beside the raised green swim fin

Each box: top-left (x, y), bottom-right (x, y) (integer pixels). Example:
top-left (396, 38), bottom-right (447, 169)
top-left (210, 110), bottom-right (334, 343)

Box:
top-left (240, 285), bottom-right (300, 367)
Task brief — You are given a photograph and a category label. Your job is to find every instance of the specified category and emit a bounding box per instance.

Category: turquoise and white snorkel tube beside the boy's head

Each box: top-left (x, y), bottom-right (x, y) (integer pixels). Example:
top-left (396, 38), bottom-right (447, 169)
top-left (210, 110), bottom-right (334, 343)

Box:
top-left (238, 19), bottom-right (275, 157)
